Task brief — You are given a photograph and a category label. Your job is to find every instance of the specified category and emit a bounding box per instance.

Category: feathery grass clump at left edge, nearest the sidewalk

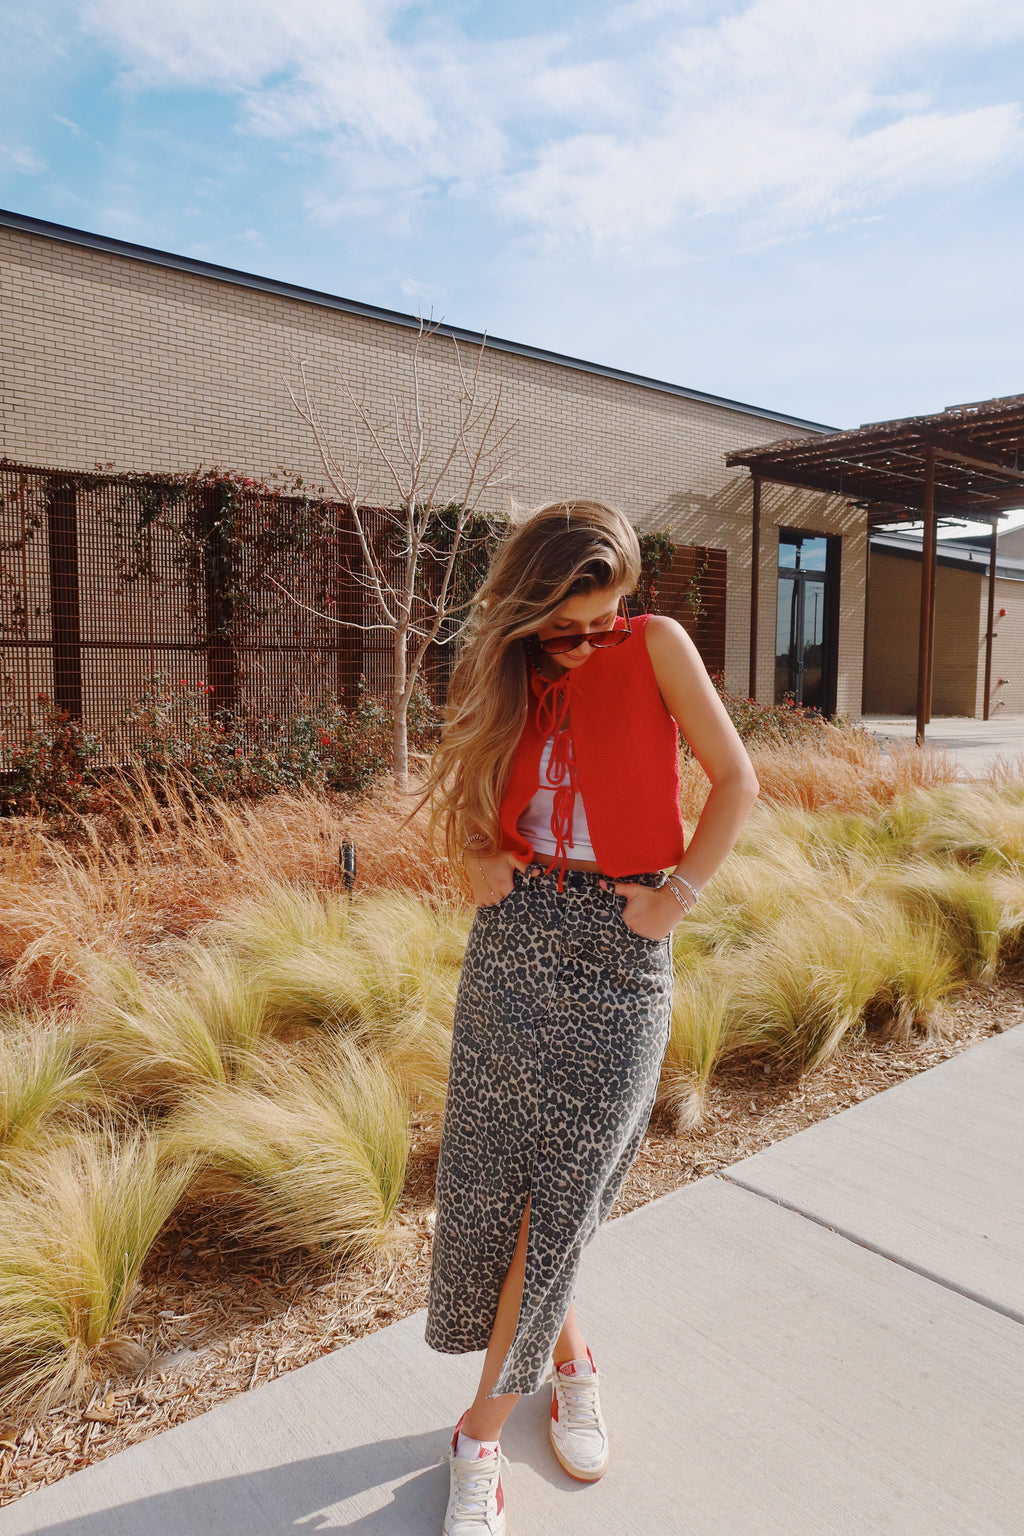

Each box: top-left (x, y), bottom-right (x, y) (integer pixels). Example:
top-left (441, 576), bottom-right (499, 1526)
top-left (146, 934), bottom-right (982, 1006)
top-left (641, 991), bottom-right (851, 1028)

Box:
top-left (0, 1130), bottom-right (192, 1416)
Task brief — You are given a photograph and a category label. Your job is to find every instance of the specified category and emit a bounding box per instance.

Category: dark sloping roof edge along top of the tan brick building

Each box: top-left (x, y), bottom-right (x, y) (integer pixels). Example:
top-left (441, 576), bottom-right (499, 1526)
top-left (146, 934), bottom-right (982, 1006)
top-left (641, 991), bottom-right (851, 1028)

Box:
top-left (0, 209), bottom-right (837, 433)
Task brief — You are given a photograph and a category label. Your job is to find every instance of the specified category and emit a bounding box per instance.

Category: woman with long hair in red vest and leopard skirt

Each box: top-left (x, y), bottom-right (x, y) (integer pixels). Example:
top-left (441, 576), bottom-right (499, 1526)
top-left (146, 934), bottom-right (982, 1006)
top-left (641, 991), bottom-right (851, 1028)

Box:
top-left (417, 501), bottom-right (757, 1536)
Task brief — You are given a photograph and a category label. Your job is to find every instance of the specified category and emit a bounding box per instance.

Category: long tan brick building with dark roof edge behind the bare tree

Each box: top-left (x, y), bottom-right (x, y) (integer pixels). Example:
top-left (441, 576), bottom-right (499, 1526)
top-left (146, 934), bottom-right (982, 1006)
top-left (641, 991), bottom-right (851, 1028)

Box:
top-left (0, 214), bottom-right (867, 716)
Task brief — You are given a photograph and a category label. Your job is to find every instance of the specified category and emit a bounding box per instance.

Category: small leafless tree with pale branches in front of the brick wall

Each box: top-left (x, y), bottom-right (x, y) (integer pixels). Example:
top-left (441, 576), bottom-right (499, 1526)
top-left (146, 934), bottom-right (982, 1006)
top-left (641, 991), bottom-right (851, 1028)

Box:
top-left (289, 316), bottom-right (514, 788)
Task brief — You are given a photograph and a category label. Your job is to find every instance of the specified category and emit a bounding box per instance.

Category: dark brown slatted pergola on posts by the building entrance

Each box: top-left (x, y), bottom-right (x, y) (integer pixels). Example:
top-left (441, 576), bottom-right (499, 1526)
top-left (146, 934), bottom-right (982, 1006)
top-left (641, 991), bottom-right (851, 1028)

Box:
top-left (726, 395), bottom-right (1024, 743)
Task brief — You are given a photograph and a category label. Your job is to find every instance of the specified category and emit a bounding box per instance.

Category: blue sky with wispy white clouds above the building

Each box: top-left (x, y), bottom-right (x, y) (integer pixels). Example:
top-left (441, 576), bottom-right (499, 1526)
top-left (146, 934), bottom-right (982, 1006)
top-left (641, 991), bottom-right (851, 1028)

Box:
top-left (0, 0), bottom-right (1024, 528)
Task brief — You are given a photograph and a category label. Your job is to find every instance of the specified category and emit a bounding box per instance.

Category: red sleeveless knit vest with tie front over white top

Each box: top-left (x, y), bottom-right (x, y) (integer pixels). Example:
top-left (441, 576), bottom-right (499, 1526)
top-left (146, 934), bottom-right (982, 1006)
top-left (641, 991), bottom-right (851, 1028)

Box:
top-left (500, 614), bottom-right (683, 879)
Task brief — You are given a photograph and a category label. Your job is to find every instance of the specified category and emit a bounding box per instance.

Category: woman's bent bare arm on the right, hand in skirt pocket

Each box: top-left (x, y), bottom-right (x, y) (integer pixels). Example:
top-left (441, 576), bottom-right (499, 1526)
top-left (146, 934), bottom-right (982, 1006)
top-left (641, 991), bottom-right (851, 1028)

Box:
top-left (616, 614), bottom-right (758, 938)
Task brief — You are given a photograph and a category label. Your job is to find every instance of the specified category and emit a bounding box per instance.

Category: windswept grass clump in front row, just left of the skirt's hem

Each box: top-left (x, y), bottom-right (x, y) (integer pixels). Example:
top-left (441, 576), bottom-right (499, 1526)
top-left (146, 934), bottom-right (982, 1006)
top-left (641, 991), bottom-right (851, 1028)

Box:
top-left (160, 1040), bottom-right (410, 1258)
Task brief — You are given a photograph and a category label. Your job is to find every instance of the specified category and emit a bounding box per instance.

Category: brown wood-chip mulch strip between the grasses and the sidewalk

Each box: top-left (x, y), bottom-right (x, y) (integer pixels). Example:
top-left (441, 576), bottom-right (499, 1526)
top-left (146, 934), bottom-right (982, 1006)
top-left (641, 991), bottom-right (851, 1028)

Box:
top-left (0, 977), bottom-right (1024, 1505)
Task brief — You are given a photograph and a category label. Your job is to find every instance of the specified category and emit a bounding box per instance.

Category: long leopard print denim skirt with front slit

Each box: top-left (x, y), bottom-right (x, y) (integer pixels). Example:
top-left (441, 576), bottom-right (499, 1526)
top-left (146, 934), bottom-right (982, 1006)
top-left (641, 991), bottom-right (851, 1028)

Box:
top-left (427, 865), bottom-right (672, 1398)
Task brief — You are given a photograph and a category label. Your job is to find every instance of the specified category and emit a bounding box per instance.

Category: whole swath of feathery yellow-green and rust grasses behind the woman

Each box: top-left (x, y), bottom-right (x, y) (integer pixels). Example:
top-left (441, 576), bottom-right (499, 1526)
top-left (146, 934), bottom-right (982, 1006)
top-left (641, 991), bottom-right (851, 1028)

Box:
top-left (0, 761), bottom-right (1024, 1415)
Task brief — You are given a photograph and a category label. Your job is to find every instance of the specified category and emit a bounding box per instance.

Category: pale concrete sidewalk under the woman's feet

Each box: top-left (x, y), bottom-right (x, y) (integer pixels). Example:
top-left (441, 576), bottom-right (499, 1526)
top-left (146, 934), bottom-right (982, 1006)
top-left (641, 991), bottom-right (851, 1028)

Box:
top-left (0, 1028), bottom-right (1024, 1536)
